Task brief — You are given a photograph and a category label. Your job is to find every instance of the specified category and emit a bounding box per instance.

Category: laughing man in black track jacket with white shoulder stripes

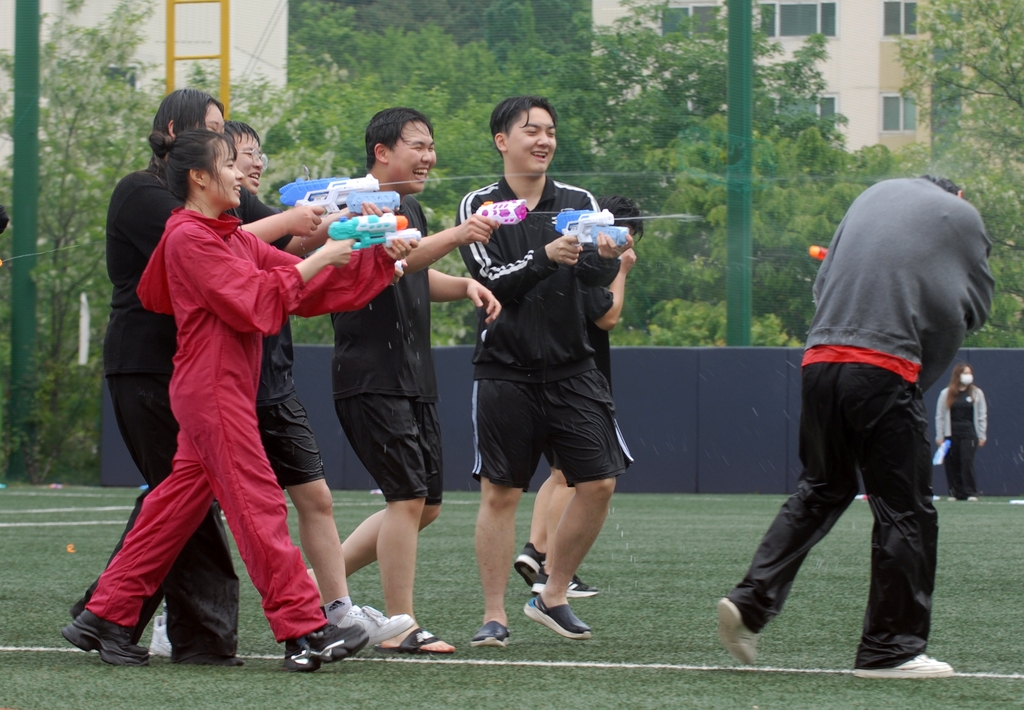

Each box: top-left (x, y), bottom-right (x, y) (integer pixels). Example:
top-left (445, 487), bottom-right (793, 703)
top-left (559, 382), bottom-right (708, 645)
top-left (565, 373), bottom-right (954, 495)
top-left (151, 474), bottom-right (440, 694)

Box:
top-left (457, 96), bottom-right (633, 645)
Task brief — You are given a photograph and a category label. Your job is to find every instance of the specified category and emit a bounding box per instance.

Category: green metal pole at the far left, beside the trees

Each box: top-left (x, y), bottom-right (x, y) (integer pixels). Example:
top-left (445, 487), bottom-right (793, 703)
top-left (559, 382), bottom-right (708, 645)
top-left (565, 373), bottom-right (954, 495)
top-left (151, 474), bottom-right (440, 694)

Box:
top-left (7, 0), bottom-right (39, 481)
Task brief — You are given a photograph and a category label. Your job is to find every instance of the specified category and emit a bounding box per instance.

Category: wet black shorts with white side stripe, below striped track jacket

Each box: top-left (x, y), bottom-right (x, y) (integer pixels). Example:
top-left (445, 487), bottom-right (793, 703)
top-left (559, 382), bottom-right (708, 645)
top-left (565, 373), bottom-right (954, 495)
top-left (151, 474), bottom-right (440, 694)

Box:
top-left (473, 370), bottom-right (629, 491)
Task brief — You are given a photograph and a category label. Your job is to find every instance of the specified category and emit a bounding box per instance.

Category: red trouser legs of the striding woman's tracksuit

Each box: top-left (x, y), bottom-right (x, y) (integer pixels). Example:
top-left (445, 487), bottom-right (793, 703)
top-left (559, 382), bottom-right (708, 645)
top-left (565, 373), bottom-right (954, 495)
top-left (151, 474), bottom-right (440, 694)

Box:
top-left (87, 407), bottom-right (327, 642)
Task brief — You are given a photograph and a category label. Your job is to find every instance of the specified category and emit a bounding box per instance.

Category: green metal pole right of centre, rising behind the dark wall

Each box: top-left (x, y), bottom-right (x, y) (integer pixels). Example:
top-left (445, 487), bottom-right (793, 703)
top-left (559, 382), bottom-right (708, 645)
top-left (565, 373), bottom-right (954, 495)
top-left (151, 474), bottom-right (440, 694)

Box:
top-left (725, 0), bottom-right (754, 345)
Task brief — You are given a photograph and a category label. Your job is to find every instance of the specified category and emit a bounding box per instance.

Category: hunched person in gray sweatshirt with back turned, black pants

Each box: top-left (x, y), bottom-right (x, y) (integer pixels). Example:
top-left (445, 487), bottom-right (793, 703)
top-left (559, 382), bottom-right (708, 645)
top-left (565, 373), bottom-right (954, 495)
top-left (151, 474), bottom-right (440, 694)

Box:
top-left (718, 175), bottom-right (993, 678)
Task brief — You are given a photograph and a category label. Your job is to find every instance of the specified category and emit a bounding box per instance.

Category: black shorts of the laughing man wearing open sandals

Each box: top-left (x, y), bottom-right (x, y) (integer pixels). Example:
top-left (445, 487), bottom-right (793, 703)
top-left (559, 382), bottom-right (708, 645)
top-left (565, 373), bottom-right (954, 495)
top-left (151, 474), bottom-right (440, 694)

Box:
top-left (334, 394), bottom-right (444, 505)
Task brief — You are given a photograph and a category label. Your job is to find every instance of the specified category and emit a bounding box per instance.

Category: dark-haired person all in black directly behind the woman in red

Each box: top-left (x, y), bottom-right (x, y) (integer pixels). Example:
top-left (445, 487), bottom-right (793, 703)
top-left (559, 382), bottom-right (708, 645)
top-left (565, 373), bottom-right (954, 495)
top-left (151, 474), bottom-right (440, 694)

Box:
top-left (71, 89), bottom-right (242, 666)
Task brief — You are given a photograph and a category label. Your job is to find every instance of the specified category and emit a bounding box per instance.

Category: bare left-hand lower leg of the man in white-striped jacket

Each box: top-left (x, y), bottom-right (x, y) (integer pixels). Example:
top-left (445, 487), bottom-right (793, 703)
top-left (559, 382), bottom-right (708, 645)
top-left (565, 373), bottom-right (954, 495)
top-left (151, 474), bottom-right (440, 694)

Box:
top-left (476, 478), bottom-right (520, 626)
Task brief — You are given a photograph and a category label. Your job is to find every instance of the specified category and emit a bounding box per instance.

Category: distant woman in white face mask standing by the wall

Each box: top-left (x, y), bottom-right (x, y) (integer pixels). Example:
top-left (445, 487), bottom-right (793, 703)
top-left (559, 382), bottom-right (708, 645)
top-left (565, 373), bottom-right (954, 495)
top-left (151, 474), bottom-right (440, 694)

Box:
top-left (935, 363), bottom-right (988, 501)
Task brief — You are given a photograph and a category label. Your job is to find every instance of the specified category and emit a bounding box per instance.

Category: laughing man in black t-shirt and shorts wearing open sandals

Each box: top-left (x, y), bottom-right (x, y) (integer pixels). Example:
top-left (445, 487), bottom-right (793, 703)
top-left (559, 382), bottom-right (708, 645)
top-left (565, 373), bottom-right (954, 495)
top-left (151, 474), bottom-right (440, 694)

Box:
top-left (332, 108), bottom-right (501, 654)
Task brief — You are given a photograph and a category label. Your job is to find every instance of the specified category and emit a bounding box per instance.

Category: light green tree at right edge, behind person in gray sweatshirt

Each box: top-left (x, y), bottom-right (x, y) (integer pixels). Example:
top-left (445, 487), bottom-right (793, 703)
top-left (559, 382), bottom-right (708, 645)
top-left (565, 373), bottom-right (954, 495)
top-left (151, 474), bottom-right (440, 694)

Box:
top-left (900, 0), bottom-right (1024, 347)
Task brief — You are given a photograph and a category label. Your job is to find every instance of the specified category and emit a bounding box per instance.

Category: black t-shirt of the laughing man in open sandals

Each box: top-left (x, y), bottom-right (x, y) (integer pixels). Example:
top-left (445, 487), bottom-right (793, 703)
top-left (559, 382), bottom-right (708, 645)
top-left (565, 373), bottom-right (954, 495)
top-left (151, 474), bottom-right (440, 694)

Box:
top-left (331, 197), bottom-right (437, 402)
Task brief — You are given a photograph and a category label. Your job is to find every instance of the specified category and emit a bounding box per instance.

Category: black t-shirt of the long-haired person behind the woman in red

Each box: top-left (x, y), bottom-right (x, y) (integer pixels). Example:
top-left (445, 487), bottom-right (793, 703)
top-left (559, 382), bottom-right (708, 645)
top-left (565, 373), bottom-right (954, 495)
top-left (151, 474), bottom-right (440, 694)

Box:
top-left (103, 171), bottom-right (181, 375)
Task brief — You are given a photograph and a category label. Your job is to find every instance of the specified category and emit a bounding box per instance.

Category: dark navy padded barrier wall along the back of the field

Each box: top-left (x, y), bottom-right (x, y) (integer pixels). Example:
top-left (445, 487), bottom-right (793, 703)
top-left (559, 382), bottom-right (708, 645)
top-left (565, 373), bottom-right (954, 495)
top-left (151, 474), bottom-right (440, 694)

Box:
top-left (101, 345), bottom-right (1024, 496)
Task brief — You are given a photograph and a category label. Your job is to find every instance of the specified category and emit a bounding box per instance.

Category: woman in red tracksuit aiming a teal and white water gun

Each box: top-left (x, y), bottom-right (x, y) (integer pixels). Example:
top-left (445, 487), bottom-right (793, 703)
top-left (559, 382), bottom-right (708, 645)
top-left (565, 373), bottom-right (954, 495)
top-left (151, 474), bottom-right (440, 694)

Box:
top-left (63, 130), bottom-right (408, 671)
